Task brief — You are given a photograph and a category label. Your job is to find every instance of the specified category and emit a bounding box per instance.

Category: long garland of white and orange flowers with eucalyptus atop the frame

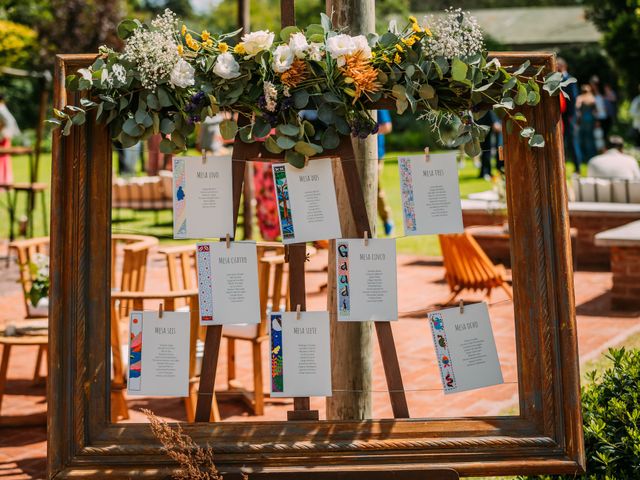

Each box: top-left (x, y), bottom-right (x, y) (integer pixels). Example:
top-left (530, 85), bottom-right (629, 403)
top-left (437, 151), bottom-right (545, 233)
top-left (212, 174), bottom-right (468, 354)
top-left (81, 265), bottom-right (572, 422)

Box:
top-left (51, 9), bottom-right (567, 166)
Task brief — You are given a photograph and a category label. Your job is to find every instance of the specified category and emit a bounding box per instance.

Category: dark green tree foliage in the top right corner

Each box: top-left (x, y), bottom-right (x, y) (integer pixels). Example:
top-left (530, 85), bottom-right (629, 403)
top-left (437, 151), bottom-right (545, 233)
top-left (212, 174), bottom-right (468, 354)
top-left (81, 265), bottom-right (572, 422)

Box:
top-left (584, 0), bottom-right (640, 96)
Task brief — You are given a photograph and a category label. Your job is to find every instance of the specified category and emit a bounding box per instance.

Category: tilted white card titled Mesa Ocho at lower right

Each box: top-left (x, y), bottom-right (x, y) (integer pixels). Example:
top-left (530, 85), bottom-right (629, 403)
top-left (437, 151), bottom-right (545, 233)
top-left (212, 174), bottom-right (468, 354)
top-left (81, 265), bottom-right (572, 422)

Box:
top-left (428, 302), bottom-right (503, 393)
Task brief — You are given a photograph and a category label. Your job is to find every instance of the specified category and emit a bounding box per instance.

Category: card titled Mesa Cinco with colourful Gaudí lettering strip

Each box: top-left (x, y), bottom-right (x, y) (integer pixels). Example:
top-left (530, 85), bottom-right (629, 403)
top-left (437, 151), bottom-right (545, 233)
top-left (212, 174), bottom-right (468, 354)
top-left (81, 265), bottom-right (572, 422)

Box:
top-left (336, 238), bottom-right (398, 322)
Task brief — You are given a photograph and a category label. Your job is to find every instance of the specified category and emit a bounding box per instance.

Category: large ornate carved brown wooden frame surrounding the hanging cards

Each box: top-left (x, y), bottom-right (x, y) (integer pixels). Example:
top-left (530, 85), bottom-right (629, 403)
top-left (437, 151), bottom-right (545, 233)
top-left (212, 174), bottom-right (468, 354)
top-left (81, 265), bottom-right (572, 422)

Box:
top-left (48, 53), bottom-right (585, 480)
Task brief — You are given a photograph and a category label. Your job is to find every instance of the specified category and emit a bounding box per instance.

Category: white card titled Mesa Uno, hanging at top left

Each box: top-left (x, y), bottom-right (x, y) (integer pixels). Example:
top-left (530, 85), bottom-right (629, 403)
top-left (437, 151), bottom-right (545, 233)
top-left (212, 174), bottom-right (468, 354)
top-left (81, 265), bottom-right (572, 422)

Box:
top-left (173, 157), bottom-right (234, 239)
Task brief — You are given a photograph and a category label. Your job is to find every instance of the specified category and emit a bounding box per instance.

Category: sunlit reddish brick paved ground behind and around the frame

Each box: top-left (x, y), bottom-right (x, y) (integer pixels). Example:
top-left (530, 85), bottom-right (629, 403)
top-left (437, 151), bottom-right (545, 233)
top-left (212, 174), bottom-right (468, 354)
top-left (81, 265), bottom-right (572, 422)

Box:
top-left (0, 246), bottom-right (640, 479)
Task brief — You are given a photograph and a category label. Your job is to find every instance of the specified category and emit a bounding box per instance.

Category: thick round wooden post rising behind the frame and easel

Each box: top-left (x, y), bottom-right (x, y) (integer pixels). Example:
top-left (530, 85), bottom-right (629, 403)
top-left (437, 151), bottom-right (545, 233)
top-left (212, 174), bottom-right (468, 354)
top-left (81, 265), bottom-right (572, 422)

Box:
top-left (327, 0), bottom-right (378, 420)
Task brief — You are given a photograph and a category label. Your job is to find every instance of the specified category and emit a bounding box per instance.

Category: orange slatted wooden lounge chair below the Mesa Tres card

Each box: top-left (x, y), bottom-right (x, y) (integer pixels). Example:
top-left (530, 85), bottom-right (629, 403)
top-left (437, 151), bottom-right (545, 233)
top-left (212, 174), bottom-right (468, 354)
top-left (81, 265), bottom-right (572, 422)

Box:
top-left (438, 232), bottom-right (513, 305)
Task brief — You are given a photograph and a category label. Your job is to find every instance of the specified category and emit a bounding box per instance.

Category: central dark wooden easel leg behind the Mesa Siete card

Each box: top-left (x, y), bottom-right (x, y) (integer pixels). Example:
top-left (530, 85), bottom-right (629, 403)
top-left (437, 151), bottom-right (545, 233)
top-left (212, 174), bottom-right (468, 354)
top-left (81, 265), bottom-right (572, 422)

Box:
top-left (287, 243), bottom-right (320, 420)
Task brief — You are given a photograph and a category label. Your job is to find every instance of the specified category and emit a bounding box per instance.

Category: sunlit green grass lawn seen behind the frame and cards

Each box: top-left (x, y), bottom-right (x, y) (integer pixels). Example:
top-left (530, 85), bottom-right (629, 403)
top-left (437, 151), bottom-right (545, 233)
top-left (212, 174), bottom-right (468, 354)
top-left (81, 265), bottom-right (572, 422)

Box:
top-left (0, 150), bottom-right (572, 255)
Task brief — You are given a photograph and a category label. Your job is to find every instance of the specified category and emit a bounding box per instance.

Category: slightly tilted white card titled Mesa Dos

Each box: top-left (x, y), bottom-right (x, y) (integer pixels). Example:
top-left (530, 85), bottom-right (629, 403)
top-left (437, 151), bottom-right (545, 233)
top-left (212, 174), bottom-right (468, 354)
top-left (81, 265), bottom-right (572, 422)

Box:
top-left (272, 158), bottom-right (341, 244)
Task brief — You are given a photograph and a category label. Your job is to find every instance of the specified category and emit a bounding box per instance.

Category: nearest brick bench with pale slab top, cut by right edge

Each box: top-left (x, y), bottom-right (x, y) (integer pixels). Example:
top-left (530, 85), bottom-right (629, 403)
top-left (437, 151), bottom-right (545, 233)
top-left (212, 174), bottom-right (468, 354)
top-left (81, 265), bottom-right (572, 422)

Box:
top-left (595, 220), bottom-right (640, 309)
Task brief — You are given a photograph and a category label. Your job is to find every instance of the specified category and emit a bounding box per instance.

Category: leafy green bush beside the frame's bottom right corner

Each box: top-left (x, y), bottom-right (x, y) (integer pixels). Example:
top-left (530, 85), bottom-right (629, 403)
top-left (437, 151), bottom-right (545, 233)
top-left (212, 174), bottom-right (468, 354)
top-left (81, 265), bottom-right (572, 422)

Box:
top-left (523, 348), bottom-right (640, 480)
